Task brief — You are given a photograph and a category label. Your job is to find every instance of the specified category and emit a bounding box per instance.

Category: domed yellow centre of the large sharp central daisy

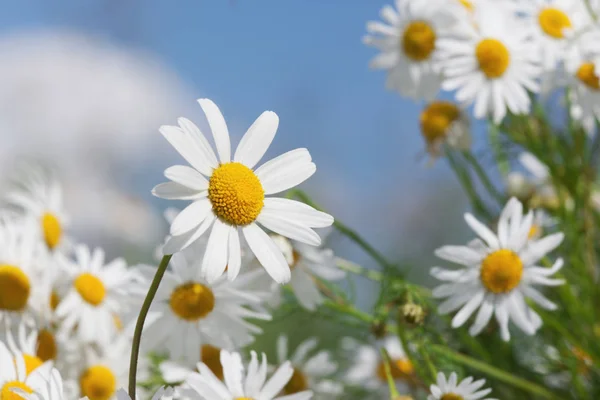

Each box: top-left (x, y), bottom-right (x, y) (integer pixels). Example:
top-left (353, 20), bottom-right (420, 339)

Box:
top-left (208, 162), bottom-right (265, 225)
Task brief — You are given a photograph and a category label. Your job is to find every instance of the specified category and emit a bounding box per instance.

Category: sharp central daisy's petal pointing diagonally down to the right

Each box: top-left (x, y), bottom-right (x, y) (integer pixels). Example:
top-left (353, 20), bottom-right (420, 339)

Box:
top-left (242, 224), bottom-right (291, 283)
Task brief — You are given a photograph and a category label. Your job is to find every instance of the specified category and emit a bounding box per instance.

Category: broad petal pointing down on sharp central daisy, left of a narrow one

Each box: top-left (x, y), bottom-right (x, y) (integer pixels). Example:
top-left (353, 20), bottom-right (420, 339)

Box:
top-left (202, 218), bottom-right (230, 283)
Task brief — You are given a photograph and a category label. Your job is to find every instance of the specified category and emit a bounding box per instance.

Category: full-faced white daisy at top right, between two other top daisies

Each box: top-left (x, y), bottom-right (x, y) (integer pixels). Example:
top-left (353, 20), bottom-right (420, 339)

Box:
top-left (436, 2), bottom-right (541, 123)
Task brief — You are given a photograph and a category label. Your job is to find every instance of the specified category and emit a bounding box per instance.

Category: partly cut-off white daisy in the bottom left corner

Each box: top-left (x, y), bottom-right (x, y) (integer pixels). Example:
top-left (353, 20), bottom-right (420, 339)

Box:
top-left (0, 342), bottom-right (52, 400)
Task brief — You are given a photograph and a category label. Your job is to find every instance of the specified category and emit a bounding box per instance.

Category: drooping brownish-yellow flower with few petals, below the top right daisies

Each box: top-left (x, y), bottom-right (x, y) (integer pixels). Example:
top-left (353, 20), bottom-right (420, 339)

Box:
top-left (419, 100), bottom-right (471, 159)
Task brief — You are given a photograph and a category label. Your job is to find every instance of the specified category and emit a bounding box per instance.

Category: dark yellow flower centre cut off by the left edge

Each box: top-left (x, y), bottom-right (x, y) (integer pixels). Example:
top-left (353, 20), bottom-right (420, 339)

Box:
top-left (0, 264), bottom-right (31, 311)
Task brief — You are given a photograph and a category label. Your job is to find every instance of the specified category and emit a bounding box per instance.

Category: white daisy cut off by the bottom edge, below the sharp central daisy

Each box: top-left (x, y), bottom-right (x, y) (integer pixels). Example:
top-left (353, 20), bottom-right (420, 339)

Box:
top-left (186, 350), bottom-right (313, 400)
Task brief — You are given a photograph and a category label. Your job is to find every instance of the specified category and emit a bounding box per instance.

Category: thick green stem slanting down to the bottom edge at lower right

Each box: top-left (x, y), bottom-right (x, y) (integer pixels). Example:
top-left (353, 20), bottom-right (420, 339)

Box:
top-left (429, 345), bottom-right (560, 400)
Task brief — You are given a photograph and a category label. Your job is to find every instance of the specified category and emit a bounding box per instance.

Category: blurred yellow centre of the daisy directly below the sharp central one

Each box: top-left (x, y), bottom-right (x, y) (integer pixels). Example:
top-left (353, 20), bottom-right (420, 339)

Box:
top-left (169, 282), bottom-right (215, 321)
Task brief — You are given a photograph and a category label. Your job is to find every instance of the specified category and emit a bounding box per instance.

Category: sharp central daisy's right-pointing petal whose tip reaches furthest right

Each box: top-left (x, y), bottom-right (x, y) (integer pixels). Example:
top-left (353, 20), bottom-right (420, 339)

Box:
top-left (262, 197), bottom-right (333, 228)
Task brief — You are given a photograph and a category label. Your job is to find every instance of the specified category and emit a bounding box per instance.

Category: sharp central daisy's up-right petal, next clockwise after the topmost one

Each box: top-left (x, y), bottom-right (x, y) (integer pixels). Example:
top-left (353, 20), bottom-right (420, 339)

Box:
top-left (233, 111), bottom-right (279, 168)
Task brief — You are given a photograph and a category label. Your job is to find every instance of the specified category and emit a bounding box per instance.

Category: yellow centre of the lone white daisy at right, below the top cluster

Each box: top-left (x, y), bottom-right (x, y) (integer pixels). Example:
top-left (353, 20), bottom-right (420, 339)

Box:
top-left (481, 249), bottom-right (523, 294)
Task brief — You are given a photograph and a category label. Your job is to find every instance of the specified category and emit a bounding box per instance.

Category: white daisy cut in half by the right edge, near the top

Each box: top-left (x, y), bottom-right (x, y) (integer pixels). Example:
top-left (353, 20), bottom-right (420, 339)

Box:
top-left (565, 28), bottom-right (600, 135)
